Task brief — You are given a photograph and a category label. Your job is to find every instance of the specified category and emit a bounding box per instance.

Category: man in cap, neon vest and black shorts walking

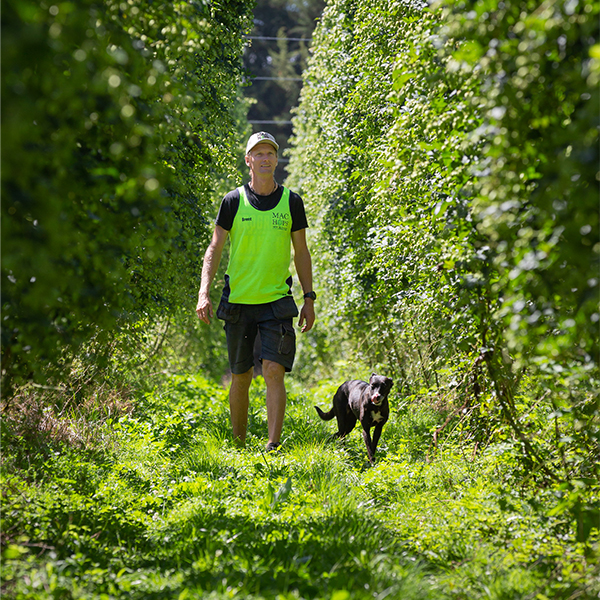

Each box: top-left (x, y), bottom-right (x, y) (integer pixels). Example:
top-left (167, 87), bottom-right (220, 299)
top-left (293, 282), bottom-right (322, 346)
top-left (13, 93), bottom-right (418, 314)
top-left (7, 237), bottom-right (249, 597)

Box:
top-left (196, 131), bottom-right (316, 451)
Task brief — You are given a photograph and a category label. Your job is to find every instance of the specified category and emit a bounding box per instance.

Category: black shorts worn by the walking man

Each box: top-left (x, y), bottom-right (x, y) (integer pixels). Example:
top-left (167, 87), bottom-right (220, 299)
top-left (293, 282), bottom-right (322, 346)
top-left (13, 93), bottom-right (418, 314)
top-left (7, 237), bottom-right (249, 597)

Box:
top-left (217, 296), bottom-right (298, 375)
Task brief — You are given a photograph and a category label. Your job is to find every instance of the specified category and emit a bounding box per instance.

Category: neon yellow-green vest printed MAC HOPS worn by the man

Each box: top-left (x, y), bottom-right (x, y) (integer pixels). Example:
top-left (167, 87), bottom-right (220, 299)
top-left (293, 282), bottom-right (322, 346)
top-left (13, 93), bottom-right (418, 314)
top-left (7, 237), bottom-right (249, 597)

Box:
top-left (227, 186), bottom-right (292, 304)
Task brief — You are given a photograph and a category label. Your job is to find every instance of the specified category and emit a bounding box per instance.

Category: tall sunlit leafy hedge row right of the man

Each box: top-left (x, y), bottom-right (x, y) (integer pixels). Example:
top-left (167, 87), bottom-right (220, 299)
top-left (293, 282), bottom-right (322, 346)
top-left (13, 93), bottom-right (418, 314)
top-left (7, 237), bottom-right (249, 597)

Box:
top-left (289, 0), bottom-right (600, 530)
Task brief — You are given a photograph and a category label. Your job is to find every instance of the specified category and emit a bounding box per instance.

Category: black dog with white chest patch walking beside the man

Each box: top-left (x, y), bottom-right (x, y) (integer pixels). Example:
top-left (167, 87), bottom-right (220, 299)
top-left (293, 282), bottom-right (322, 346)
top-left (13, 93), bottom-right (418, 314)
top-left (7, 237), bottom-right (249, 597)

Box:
top-left (315, 373), bottom-right (394, 464)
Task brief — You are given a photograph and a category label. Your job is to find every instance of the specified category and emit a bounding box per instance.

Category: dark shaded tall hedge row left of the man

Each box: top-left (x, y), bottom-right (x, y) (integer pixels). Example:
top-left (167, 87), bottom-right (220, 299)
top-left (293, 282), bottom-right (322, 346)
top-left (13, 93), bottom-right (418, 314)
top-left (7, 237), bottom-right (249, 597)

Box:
top-left (2, 0), bottom-right (250, 393)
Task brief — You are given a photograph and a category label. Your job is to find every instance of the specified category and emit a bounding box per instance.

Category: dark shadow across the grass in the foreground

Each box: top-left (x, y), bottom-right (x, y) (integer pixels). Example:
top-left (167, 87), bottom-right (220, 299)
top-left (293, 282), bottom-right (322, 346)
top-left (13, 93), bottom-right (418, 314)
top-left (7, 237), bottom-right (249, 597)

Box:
top-left (143, 507), bottom-right (436, 598)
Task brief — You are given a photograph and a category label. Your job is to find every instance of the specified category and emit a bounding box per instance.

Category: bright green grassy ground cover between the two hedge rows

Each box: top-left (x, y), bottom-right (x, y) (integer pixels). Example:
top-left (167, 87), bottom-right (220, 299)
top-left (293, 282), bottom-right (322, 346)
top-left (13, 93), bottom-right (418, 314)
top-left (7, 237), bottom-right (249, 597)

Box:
top-left (2, 376), bottom-right (600, 600)
